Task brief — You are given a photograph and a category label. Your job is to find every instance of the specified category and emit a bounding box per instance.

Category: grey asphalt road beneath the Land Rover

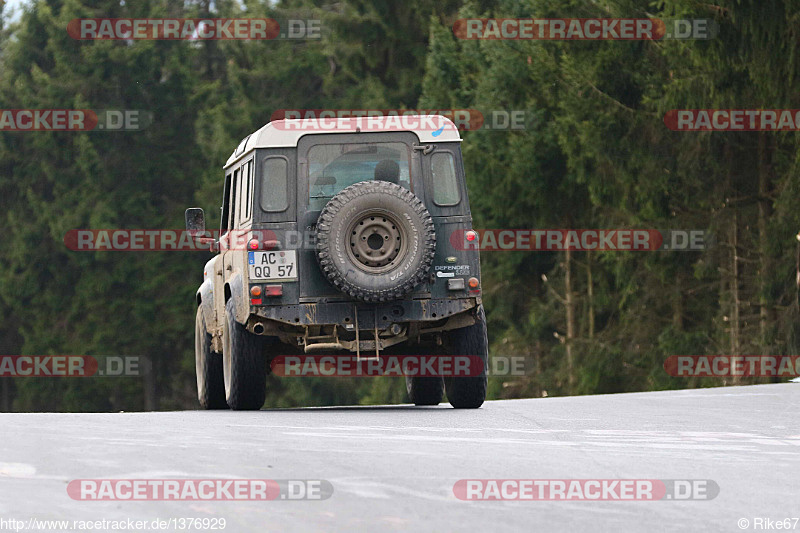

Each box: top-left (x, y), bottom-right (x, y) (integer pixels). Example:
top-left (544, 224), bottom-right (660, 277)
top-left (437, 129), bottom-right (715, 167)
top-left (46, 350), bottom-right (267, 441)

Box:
top-left (0, 383), bottom-right (800, 533)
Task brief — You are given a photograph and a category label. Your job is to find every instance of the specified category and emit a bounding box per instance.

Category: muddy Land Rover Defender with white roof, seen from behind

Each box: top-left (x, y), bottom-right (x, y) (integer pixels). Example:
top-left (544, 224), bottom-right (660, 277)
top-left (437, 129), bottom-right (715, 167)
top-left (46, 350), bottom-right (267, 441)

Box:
top-left (186, 115), bottom-right (488, 410)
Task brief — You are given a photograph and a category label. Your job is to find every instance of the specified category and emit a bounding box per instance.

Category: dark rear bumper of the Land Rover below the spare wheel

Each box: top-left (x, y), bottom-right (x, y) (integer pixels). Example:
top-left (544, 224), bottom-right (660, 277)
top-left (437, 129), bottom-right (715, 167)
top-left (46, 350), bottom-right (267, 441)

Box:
top-left (250, 297), bottom-right (481, 330)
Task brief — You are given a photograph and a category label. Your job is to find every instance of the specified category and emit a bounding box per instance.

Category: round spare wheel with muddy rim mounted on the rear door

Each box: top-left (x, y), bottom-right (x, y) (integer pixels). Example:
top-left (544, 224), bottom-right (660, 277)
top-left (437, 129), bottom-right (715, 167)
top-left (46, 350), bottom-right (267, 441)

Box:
top-left (316, 181), bottom-right (436, 302)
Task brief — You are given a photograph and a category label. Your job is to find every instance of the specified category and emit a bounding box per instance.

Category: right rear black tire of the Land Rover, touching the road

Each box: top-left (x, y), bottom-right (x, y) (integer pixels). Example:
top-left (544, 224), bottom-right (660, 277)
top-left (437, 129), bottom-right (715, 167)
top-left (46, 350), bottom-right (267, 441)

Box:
top-left (444, 307), bottom-right (489, 409)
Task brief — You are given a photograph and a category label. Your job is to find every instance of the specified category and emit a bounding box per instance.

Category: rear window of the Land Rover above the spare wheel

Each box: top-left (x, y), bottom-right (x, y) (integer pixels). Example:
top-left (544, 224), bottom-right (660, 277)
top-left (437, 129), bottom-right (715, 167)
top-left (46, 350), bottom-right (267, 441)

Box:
top-left (308, 142), bottom-right (411, 210)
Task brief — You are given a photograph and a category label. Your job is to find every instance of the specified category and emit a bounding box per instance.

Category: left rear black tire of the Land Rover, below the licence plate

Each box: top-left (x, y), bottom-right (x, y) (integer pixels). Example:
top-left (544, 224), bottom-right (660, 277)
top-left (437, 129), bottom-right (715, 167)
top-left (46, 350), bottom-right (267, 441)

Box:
top-left (222, 298), bottom-right (267, 411)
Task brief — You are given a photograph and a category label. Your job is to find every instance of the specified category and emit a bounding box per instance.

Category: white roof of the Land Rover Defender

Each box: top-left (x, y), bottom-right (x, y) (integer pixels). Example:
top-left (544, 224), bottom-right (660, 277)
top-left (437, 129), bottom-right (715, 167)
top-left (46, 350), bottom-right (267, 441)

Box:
top-left (225, 115), bottom-right (461, 168)
